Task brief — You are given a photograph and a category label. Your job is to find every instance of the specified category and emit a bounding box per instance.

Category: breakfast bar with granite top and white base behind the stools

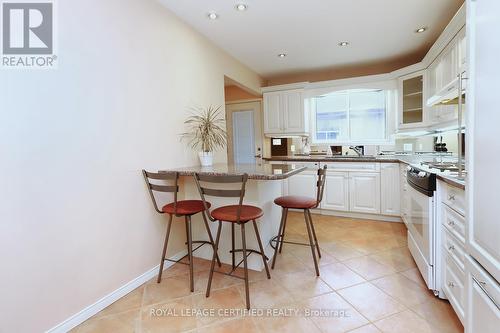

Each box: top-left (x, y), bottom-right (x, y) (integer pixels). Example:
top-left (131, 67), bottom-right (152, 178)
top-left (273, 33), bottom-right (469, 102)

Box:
top-left (159, 161), bottom-right (306, 271)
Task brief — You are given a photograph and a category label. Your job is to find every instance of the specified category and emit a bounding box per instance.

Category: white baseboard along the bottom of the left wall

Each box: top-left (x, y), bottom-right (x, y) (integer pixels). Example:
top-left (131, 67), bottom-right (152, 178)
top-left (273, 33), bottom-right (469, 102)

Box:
top-left (47, 250), bottom-right (187, 333)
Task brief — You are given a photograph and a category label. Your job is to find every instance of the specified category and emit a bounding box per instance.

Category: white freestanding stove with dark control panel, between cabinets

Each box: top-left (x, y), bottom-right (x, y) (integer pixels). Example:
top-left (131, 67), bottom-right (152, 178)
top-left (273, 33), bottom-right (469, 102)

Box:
top-left (405, 166), bottom-right (444, 298)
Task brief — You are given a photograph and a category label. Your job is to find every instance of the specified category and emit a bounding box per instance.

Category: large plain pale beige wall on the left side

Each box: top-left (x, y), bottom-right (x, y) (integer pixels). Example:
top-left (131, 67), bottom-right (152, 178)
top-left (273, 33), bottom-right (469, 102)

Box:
top-left (0, 0), bottom-right (261, 332)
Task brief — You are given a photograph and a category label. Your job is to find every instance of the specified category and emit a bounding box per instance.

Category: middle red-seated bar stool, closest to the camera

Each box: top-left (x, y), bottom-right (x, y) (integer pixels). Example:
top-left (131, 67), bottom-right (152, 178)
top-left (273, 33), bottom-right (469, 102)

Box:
top-left (194, 173), bottom-right (271, 309)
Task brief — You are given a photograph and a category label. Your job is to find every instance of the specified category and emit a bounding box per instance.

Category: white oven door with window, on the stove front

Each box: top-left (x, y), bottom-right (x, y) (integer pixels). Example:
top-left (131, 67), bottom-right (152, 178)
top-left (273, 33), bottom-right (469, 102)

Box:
top-left (407, 183), bottom-right (434, 268)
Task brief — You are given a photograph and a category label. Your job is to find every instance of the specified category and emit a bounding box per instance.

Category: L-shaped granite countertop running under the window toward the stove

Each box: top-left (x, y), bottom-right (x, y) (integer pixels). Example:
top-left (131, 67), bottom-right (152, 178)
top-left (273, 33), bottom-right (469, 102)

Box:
top-left (264, 155), bottom-right (466, 190)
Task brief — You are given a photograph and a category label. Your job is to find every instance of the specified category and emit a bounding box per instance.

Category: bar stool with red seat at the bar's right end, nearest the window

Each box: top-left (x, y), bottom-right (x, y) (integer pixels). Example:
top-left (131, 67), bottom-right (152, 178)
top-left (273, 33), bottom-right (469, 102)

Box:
top-left (271, 165), bottom-right (326, 276)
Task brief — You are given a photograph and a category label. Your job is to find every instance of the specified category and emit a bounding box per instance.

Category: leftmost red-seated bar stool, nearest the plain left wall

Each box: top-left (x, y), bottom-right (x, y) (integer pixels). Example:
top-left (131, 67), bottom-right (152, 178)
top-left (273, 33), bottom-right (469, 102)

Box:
top-left (142, 170), bottom-right (221, 292)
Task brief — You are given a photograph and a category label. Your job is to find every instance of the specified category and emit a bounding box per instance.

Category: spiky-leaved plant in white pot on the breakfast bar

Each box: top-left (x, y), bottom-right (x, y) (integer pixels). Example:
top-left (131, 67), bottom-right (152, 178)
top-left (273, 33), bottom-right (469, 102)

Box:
top-left (182, 106), bottom-right (227, 166)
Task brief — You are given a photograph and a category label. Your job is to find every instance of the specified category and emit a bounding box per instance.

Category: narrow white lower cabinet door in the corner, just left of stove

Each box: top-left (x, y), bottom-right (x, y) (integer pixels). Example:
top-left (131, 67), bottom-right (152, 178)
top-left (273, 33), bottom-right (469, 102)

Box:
top-left (380, 163), bottom-right (401, 216)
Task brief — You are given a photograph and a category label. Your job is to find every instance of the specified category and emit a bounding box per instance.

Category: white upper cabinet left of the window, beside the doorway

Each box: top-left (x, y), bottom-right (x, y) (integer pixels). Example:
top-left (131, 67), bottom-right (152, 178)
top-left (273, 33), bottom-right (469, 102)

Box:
top-left (263, 89), bottom-right (309, 135)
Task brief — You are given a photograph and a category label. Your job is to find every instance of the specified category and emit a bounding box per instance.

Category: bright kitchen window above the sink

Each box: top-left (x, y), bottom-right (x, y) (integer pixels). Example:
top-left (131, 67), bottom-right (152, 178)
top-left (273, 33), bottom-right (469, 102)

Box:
top-left (312, 89), bottom-right (387, 143)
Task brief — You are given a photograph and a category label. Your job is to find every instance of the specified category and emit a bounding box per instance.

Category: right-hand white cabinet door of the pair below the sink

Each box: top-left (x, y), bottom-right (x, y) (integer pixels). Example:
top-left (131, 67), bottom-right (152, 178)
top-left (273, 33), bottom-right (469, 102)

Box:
top-left (349, 172), bottom-right (380, 214)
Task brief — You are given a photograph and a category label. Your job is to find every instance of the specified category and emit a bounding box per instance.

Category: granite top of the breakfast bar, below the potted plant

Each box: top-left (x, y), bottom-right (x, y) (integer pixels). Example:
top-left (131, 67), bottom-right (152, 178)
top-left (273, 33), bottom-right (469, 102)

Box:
top-left (158, 161), bottom-right (307, 180)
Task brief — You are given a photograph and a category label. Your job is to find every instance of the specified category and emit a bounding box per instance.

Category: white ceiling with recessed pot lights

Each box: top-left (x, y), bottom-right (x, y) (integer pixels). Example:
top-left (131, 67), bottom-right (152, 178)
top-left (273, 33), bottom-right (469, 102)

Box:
top-left (159, 0), bottom-right (463, 78)
